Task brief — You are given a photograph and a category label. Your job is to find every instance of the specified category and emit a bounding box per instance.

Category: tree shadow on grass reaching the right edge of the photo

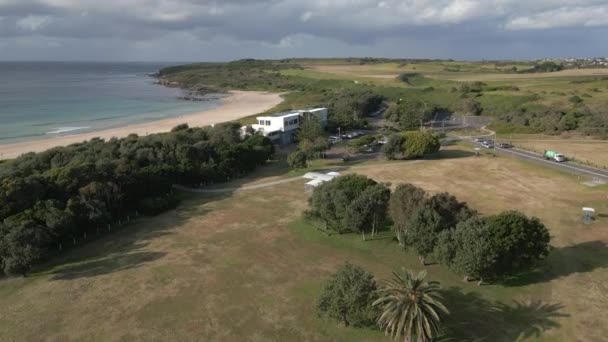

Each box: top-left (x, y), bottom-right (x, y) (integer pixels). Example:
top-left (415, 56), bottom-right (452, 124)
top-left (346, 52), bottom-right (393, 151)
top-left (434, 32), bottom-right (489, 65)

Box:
top-left (503, 241), bottom-right (608, 286)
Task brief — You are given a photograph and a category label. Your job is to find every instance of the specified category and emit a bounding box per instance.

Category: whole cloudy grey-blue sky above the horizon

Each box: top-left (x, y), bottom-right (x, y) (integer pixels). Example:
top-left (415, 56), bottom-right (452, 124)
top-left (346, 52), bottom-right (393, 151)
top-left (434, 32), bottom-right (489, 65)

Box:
top-left (0, 0), bottom-right (608, 62)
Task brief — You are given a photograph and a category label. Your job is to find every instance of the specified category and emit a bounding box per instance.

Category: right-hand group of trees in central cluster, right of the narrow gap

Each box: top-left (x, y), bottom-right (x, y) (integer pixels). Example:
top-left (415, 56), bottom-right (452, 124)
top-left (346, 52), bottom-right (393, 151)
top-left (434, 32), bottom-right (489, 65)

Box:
top-left (389, 184), bottom-right (550, 283)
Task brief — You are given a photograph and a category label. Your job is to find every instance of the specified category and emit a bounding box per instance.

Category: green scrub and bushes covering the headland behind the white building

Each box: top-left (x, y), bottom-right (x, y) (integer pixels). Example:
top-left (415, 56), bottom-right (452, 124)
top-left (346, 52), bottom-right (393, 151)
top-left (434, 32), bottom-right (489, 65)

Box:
top-left (159, 58), bottom-right (608, 137)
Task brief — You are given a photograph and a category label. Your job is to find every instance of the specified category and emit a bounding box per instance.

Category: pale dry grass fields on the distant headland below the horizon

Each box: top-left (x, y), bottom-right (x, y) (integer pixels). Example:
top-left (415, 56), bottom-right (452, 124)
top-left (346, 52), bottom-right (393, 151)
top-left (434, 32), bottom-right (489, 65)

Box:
top-left (300, 61), bottom-right (608, 114)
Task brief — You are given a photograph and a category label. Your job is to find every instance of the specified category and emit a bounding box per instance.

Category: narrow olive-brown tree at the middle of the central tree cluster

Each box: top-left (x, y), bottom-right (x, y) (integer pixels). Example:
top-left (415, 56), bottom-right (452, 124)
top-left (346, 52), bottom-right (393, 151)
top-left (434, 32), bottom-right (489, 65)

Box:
top-left (389, 183), bottom-right (426, 245)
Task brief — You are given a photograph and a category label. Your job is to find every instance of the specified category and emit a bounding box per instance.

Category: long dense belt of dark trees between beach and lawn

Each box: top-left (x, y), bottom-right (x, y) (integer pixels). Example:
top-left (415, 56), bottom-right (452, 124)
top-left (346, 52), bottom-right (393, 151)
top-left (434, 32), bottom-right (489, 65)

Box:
top-left (0, 124), bottom-right (274, 275)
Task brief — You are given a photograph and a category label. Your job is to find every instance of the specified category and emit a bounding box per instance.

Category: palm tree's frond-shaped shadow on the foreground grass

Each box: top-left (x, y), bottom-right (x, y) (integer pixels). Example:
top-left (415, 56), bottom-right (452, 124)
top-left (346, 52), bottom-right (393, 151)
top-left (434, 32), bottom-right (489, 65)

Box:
top-left (443, 287), bottom-right (569, 341)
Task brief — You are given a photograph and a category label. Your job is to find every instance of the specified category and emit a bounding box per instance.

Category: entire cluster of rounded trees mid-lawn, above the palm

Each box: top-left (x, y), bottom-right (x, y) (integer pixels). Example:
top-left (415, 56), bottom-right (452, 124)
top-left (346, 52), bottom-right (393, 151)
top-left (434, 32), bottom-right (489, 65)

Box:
top-left (306, 175), bottom-right (550, 283)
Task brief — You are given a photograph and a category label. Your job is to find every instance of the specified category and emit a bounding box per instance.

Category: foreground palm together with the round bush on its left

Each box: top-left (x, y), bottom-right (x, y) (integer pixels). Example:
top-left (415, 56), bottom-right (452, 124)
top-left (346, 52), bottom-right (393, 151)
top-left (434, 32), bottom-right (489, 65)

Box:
top-left (316, 263), bottom-right (449, 341)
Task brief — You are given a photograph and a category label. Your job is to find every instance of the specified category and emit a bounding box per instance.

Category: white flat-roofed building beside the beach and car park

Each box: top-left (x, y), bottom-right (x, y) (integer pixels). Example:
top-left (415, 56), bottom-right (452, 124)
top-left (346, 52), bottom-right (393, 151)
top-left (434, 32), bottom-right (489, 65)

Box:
top-left (251, 108), bottom-right (327, 144)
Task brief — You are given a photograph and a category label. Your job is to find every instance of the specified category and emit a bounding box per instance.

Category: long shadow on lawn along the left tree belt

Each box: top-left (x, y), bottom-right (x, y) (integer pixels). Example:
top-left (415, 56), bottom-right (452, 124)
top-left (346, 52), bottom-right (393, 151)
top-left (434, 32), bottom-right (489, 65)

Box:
top-left (33, 193), bottom-right (238, 280)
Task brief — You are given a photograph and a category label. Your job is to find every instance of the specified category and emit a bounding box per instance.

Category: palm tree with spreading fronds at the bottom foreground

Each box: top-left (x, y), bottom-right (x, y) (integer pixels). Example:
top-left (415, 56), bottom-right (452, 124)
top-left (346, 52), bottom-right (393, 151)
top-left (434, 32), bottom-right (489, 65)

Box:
top-left (373, 270), bottom-right (449, 342)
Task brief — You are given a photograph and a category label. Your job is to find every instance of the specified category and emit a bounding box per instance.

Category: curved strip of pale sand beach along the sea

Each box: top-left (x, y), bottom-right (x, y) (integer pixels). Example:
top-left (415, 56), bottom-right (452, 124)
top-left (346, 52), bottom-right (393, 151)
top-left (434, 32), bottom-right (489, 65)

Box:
top-left (0, 91), bottom-right (283, 159)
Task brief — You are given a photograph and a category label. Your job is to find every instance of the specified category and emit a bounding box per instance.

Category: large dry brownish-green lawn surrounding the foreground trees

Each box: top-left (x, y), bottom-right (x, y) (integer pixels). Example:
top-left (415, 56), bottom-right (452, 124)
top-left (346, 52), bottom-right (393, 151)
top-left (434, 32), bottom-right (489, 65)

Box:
top-left (0, 146), bottom-right (608, 341)
